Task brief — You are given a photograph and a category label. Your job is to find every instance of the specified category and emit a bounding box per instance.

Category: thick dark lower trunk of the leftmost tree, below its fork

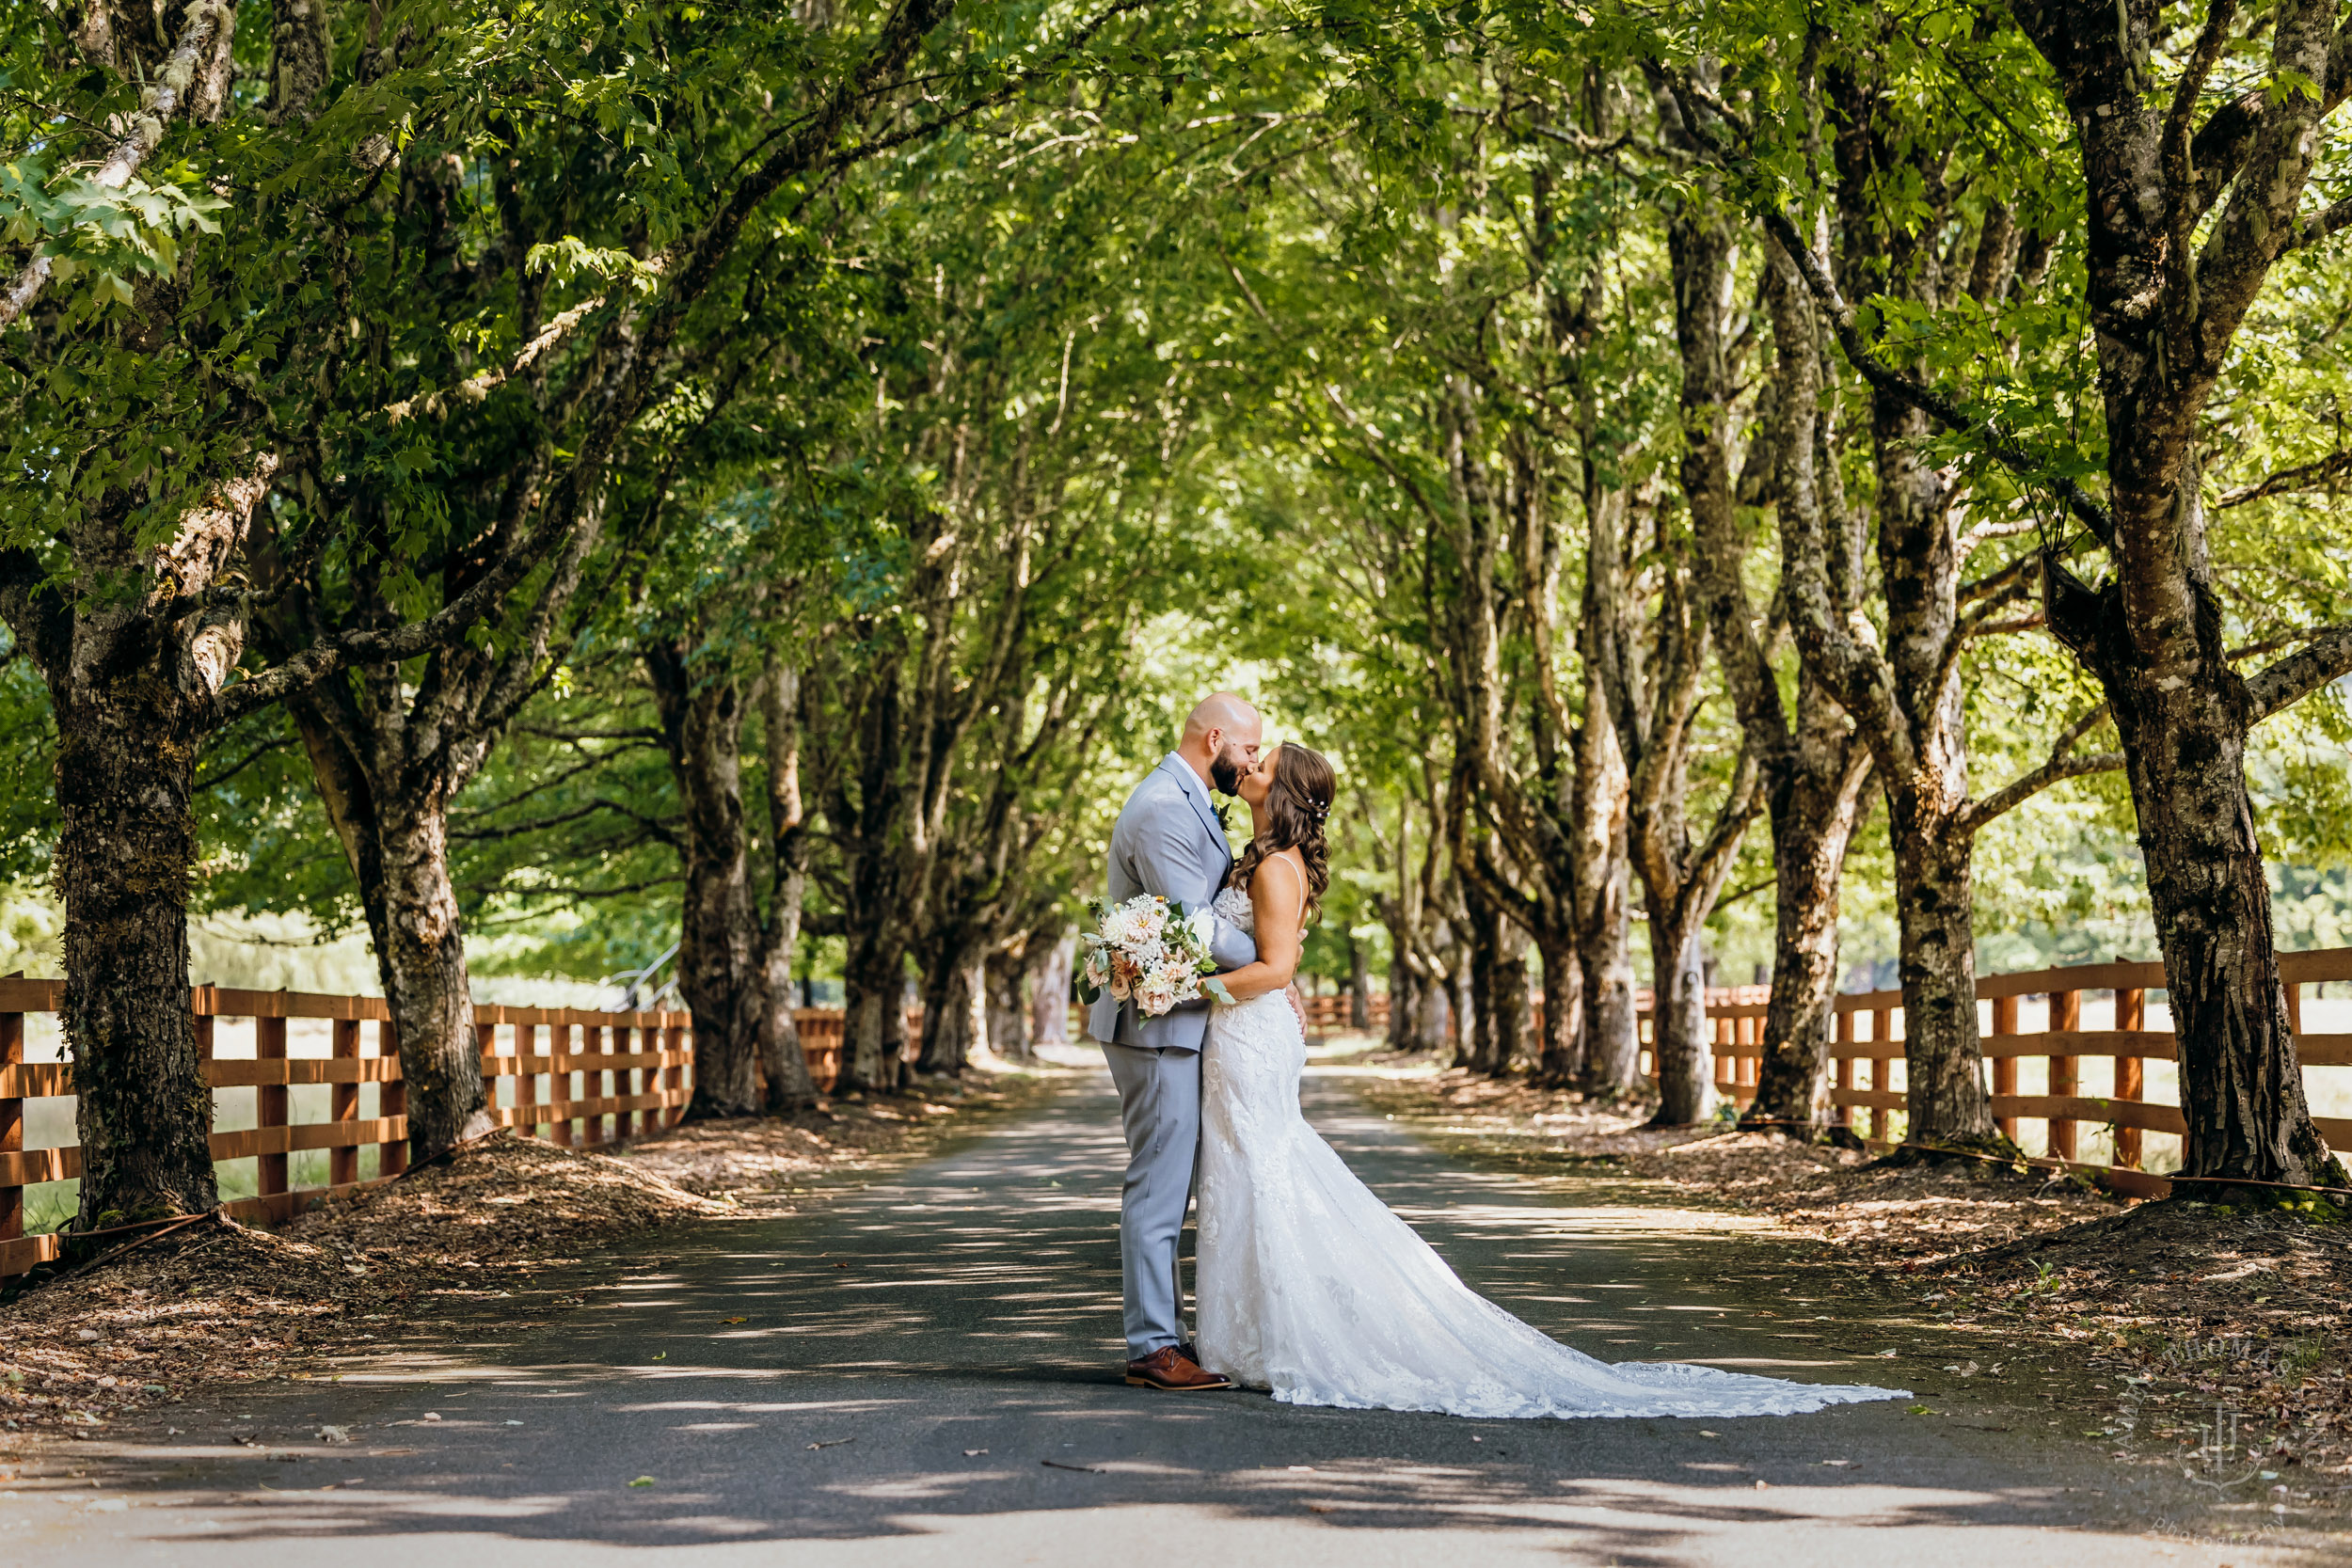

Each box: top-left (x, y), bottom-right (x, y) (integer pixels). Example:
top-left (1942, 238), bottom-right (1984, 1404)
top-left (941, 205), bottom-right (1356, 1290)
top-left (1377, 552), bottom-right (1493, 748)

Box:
top-left (52, 657), bottom-right (219, 1229)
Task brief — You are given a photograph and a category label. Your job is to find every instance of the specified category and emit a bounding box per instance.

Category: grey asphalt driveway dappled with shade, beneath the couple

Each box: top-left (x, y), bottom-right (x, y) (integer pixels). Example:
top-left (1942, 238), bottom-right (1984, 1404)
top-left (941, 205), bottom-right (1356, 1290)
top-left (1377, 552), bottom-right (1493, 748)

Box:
top-left (0, 1069), bottom-right (2296, 1568)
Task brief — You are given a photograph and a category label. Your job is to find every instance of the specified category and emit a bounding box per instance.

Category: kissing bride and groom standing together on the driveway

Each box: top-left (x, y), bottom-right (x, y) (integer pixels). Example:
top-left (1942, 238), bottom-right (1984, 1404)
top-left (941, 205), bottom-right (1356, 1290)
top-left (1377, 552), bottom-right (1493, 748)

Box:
top-left (1087, 691), bottom-right (1903, 1418)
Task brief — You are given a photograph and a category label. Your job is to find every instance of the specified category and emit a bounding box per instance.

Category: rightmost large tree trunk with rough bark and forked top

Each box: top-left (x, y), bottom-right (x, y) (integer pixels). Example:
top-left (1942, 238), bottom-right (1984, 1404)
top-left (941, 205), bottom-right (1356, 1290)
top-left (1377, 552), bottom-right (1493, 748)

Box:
top-left (2016, 0), bottom-right (2352, 1201)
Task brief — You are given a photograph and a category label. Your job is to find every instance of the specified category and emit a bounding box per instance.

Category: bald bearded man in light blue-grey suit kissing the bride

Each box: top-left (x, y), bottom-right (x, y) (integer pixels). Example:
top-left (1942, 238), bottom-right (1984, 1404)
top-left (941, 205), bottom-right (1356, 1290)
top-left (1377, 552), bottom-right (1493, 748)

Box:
top-left (1087, 691), bottom-right (1263, 1392)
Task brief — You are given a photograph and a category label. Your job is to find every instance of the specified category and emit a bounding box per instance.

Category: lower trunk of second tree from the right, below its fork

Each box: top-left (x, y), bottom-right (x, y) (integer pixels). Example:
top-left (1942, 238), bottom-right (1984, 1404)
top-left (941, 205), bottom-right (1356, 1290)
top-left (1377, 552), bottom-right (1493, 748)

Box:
top-left (1886, 790), bottom-right (2004, 1149)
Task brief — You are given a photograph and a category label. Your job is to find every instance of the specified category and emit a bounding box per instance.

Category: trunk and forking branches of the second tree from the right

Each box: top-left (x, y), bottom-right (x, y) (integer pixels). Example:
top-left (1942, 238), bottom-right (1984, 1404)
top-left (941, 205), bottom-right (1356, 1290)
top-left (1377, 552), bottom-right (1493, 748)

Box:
top-left (1722, 56), bottom-right (2122, 1149)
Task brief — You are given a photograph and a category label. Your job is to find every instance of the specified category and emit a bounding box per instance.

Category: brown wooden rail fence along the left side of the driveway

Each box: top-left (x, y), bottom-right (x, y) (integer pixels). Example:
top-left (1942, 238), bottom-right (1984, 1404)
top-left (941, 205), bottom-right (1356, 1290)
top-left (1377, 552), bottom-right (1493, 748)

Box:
top-left (0, 978), bottom-right (922, 1279)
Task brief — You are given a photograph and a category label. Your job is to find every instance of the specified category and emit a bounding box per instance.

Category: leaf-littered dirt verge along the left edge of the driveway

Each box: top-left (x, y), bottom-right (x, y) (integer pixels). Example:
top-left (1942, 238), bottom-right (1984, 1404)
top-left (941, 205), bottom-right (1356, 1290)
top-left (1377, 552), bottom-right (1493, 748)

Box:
top-left (0, 1063), bottom-right (1077, 1483)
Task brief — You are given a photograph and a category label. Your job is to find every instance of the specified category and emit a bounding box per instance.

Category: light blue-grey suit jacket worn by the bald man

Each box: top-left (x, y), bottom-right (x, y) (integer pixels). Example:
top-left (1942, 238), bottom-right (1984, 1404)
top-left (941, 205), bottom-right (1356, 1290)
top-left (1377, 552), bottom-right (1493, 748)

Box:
top-left (1087, 752), bottom-right (1259, 1051)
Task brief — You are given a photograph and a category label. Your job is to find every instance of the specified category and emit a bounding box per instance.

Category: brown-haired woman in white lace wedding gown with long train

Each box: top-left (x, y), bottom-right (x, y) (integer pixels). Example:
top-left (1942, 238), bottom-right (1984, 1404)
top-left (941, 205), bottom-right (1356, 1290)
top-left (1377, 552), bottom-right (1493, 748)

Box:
top-left (1195, 745), bottom-right (1903, 1418)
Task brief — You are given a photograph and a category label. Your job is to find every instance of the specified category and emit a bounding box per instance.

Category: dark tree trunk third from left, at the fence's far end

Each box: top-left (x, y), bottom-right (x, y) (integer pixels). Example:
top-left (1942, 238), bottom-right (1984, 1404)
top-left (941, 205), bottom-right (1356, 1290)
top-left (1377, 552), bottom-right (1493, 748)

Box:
top-left (644, 641), bottom-right (767, 1121)
